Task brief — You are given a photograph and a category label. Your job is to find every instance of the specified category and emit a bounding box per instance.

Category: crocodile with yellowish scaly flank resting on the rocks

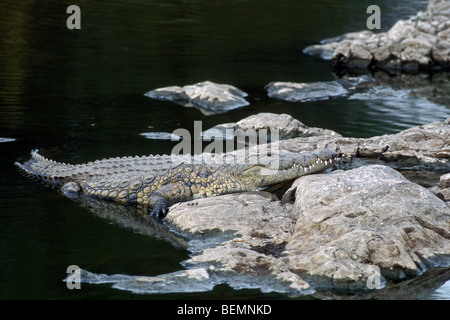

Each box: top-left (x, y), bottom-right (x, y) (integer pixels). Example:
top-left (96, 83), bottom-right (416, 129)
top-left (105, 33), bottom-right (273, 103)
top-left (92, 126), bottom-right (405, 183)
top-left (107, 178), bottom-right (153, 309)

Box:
top-left (15, 149), bottom-right (337, 218)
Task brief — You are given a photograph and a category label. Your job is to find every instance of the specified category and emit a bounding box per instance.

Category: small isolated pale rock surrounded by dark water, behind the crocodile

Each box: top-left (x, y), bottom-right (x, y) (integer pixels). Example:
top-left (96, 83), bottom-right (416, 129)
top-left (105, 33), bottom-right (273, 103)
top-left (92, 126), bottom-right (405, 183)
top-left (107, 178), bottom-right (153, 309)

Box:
top-left (144, 81), bottom-right (249, 115)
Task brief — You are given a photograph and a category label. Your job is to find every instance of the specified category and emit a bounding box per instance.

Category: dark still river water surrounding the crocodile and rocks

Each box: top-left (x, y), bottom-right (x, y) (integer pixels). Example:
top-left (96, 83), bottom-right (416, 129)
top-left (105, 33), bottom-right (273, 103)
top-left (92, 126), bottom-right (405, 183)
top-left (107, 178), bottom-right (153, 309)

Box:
top-left (0, 0), bottom-right (450, 299)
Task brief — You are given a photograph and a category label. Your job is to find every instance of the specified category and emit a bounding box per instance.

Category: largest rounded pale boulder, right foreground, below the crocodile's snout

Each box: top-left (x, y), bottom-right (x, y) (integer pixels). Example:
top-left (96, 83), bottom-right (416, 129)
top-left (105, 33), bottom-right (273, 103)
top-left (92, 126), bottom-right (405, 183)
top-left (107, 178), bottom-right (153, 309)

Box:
top-left (283, 165), bottom-right (450, 288)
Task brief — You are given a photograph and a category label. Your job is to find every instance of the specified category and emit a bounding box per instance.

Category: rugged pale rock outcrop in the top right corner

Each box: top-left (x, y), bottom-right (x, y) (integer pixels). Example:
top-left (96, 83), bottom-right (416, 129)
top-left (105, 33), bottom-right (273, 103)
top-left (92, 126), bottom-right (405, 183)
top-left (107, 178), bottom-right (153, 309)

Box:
top-left (303, 0), bottom-right (450, 71)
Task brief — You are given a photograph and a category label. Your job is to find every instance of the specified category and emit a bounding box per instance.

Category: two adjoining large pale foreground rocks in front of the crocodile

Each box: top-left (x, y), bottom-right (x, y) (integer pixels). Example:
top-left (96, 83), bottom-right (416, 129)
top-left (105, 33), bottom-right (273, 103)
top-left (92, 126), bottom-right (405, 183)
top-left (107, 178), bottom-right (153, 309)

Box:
top-left (167, 165), bottom-right (450, 293)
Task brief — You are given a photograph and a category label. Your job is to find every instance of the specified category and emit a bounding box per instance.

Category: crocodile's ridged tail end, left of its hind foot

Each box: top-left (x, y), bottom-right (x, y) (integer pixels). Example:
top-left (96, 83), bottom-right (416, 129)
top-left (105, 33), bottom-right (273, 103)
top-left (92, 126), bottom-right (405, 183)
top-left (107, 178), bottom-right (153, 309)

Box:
top-left (15, 150), bottom-right (73, 189)
